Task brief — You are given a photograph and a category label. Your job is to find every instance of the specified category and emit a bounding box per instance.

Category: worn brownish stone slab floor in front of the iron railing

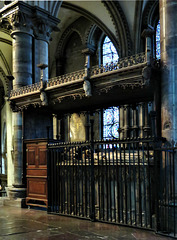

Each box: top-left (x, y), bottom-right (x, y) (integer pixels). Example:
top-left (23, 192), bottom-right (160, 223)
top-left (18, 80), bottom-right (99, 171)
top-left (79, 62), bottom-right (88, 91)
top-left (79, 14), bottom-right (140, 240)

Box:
top-left (0, 206), bottom-right (174, 240)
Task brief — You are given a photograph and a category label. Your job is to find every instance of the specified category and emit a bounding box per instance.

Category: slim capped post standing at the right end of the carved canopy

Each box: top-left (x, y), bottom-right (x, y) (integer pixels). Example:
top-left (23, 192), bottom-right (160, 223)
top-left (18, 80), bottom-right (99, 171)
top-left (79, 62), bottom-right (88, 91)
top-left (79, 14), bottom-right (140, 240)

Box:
top-left (142, 27), bottom-right (155, 65)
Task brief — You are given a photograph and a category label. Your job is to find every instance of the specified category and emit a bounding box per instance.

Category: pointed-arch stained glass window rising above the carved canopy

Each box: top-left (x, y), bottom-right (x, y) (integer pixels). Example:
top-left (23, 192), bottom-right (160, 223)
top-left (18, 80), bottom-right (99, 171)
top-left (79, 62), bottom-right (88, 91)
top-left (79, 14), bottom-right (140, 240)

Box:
top-left (102, 36), bottom-right (119, 65)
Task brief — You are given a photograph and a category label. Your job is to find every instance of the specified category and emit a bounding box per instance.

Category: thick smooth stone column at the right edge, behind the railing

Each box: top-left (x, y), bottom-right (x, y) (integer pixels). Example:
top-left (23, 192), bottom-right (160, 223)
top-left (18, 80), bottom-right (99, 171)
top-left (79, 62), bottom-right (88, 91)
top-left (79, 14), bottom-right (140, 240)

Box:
top-left (159, 0), bottom-right (177, 142)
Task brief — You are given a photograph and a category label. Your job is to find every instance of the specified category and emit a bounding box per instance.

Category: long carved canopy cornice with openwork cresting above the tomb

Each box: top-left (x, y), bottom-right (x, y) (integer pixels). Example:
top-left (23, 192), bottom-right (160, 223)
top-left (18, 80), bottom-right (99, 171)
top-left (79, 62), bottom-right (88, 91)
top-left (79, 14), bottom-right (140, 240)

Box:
top-left (10, 53), bottom-right (154, 110)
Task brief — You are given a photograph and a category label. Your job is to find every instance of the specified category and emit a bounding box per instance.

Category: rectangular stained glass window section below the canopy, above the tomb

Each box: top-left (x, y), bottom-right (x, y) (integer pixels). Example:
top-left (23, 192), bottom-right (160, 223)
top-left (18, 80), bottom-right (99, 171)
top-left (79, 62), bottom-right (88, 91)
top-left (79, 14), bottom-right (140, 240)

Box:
top-left (103, 107), bottom-right (119, 140)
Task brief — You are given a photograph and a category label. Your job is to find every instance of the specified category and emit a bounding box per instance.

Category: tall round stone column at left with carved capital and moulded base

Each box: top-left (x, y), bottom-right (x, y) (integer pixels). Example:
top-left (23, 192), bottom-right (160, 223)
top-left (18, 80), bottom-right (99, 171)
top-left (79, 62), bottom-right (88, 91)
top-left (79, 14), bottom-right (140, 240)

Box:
top-left (1, 5), bottom-right (33, 198)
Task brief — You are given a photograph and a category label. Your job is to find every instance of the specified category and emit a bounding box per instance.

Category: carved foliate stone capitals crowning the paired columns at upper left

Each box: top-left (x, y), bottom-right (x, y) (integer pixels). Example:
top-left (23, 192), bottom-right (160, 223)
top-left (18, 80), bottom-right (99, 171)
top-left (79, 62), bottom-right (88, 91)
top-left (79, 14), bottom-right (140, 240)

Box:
top-left (0, 1), bottom-right (60, 41)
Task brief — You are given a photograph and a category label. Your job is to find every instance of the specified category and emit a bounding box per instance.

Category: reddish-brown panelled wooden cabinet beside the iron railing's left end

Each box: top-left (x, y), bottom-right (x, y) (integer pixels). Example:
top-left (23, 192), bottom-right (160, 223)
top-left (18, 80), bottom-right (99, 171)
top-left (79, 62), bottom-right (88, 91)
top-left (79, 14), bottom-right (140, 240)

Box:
top-left (25, 140), bottom-right (47, 207)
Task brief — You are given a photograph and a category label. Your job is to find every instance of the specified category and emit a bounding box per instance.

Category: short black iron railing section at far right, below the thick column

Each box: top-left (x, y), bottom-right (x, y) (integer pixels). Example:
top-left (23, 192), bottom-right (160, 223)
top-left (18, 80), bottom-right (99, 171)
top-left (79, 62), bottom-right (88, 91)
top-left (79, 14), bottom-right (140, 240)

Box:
top-left (155, 146), bottom-right (177, 238)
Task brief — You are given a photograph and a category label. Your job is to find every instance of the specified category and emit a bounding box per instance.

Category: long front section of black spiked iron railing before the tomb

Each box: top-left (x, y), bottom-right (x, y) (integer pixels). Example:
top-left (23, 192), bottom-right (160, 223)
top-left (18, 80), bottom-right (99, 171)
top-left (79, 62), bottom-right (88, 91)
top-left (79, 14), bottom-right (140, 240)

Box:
top-left (48, 139), bottom-right (156, 229)
